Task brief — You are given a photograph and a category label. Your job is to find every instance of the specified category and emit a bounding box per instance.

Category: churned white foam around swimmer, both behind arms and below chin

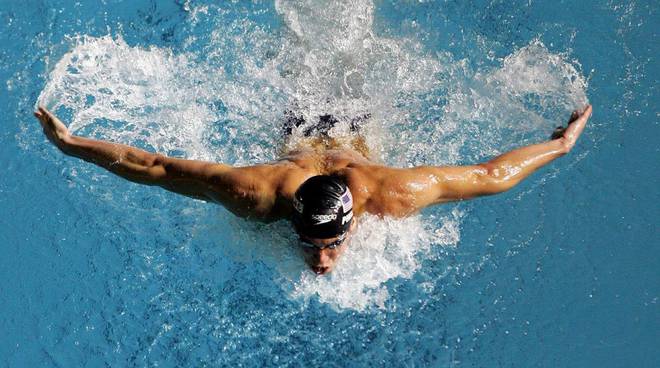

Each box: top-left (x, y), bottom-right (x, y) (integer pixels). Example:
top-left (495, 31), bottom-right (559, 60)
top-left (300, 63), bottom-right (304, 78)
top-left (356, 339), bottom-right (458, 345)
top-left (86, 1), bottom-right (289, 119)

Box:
top-left (39, 1), bottom-right (586, 310)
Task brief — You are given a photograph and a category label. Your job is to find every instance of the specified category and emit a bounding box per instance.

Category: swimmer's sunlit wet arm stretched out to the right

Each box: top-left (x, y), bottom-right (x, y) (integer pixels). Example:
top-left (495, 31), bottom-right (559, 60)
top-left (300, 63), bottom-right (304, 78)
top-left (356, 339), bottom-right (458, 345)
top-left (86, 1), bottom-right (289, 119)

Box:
top-left (374, 105), bottom-right (591, 212)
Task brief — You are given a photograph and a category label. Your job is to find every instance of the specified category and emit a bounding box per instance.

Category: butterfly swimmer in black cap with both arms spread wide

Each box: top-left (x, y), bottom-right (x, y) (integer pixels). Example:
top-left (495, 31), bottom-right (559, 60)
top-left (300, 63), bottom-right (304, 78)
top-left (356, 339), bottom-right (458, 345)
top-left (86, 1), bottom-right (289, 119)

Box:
top-left (34, 105), bottom-right (592, 275)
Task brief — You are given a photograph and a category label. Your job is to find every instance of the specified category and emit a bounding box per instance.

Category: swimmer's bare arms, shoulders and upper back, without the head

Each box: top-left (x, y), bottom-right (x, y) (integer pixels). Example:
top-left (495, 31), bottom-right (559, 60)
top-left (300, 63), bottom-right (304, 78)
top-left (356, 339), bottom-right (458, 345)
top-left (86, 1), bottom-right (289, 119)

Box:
top-left (34, 105), bottom-right (592, 221)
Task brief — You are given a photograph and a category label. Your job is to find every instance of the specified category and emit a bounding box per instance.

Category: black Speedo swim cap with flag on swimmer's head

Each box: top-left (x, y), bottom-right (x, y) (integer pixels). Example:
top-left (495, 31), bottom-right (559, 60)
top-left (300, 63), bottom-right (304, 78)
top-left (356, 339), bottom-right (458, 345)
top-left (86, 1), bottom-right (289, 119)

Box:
top-left (293, 175), bottom-right (353, 239)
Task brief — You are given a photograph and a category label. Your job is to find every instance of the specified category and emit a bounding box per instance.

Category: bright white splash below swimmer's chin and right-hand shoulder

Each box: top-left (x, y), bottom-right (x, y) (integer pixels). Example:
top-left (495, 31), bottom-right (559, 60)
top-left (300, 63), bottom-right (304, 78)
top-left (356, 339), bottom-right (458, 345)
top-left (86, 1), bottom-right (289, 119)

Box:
top-left (292, 216), bottom-right (460, 310)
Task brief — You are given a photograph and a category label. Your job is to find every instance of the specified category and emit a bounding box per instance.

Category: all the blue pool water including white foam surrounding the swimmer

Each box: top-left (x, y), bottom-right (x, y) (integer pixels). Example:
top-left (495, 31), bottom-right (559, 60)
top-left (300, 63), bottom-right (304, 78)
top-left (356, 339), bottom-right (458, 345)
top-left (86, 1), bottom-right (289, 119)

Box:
top-left (0, 0), bottom-right (660, 367)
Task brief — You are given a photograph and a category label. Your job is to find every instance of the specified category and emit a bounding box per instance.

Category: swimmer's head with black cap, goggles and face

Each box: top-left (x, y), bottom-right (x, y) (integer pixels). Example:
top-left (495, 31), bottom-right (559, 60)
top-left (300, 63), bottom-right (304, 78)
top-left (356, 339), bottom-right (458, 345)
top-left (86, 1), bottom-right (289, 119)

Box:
top-left (293, 175), bottom-right (355, 274)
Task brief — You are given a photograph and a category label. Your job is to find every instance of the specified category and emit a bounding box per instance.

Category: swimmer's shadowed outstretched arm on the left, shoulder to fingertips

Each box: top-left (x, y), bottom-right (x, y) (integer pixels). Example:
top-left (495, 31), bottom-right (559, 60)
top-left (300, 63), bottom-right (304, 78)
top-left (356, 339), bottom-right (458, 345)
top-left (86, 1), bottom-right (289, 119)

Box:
top-left (34, 107), bottom-right (284, 217)
